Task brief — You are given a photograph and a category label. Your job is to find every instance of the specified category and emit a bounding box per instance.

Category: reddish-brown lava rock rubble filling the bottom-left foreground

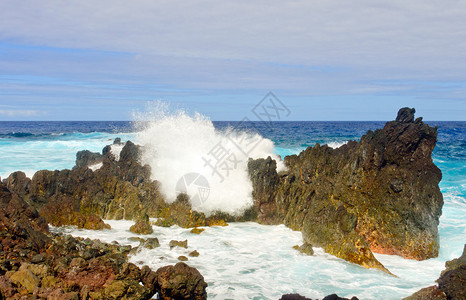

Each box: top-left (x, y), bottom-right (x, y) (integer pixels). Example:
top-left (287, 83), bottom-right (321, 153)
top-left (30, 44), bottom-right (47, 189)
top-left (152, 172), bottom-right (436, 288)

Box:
top-left (0, 183), bottom-right (207, 299)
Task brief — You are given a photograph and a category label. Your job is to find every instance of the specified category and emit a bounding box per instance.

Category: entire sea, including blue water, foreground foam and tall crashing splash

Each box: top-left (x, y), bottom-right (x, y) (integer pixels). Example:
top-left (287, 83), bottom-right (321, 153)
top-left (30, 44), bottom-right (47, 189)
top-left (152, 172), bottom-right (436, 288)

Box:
top-left (0, 118), bottom-right (466, 299)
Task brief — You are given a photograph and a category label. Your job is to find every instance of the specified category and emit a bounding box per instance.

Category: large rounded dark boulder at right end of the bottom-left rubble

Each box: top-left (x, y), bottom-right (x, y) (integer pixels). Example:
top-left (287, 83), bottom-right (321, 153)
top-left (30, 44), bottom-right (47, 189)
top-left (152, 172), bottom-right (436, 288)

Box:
top-left (156, 262), bottom-right (207, 300)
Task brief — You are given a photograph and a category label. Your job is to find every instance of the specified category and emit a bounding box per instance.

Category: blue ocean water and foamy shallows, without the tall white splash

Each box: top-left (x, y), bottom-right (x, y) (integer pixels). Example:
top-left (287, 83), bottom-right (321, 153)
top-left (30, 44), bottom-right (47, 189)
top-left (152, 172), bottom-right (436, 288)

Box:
top-left (0, 122), bottom-right (466, 299)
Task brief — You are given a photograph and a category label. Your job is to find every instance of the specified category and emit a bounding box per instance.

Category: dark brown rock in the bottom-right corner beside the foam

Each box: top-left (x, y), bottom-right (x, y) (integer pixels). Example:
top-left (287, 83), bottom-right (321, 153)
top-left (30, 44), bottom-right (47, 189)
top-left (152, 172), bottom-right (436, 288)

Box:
top-left (404, 244), bottom-right (466, 300)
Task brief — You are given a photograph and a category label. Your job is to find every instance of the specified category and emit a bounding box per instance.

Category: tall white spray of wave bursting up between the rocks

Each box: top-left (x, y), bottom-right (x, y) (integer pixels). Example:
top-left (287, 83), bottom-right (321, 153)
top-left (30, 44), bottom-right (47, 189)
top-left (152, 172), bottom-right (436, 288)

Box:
top-left (136, 103), bottom-right (284, 214)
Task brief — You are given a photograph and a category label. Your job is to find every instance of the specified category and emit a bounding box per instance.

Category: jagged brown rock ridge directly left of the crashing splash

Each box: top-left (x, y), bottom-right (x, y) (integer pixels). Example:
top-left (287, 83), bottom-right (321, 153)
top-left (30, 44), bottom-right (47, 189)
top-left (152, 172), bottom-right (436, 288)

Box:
top-left (6, 141), bottom-right (167, 229)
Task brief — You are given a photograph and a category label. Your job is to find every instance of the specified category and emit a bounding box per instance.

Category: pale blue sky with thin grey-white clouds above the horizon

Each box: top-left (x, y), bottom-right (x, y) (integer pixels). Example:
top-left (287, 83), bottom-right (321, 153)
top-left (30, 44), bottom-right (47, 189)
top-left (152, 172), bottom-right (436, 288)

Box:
top-left (0, 0), bottom-right (466, 121)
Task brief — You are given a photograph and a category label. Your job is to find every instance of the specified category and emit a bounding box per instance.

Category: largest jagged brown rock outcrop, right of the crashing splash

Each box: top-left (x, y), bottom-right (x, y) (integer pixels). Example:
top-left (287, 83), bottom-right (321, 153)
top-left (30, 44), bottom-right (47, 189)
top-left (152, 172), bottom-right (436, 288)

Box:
top-left (248, 108), bottom-right (443, 271)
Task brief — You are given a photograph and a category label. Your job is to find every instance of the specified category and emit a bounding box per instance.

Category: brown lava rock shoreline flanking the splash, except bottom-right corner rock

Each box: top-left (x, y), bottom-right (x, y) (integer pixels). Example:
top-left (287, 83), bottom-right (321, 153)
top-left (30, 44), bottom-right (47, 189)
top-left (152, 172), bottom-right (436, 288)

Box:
top-left (0, 108), bottom-right (460, 299)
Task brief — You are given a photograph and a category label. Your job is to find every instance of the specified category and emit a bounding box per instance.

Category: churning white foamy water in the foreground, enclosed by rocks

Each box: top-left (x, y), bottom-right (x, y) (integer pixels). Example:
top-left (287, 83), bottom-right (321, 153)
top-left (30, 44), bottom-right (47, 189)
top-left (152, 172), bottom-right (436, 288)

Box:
top-left (60, 220), bottom-right (452, 299)
